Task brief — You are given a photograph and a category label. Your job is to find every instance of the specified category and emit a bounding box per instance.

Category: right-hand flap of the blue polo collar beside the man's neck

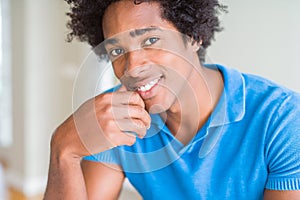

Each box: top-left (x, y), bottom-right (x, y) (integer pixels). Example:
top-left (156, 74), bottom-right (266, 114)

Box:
top-left (199, 65), bottom-right (246, 158)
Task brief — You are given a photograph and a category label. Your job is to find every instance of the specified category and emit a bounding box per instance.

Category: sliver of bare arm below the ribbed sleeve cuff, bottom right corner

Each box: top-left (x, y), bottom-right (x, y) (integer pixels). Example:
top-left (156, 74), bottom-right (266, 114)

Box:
top-left (264, 190), bottom-right (300, 200)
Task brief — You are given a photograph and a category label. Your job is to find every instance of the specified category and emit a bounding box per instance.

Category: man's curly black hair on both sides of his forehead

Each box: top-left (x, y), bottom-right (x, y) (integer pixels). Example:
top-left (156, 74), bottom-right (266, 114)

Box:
top-left (65, 0), bottom-right (227, 59)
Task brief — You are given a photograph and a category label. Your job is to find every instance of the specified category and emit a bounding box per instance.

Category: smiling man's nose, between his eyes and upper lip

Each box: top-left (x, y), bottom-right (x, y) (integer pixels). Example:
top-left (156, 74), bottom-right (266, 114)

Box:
top-left (125, 49), bottom-right (150, 78)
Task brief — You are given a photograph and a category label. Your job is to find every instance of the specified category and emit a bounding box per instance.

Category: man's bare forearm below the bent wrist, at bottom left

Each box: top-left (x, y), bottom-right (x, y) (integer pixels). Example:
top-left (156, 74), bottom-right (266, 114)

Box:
top-left (44, 152), bottom-right (88, 200)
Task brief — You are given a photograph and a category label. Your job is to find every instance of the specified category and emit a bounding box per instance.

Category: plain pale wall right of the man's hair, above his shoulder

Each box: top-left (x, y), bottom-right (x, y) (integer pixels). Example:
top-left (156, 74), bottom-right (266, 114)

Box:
top-left (208, 0), bottom-right (300, 91)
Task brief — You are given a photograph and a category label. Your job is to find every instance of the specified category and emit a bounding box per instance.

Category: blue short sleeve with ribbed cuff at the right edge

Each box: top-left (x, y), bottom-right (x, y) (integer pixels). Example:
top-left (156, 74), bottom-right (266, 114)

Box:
top-left (265, 94), bottom-right (300, 190)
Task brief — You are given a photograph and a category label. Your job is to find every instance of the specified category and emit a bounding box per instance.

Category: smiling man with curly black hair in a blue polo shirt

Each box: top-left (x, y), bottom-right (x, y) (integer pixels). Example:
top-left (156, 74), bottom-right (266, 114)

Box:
top-left (45, 0), bottom-right (300, 200)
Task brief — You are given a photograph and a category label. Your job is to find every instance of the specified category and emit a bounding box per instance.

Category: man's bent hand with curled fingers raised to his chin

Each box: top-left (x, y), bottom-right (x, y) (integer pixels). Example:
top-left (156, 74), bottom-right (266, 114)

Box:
top-left (51, 86), bottom-right (150, 157)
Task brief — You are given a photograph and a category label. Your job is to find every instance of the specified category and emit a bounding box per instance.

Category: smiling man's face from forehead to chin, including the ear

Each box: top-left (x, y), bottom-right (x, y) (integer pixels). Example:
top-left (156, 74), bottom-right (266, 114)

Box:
top-left (103, 0), bottom-right (197, 113)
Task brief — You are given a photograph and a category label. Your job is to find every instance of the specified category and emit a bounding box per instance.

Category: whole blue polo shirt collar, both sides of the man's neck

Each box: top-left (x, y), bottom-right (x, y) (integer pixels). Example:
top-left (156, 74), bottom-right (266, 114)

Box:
top-left (147, 65), bottom-right (246, 158)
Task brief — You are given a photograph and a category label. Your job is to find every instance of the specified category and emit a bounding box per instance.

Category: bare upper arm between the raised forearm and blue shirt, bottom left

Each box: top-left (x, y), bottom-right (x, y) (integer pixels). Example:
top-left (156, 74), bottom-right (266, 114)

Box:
top-left (81, 160), bottom-right (124, 199)
